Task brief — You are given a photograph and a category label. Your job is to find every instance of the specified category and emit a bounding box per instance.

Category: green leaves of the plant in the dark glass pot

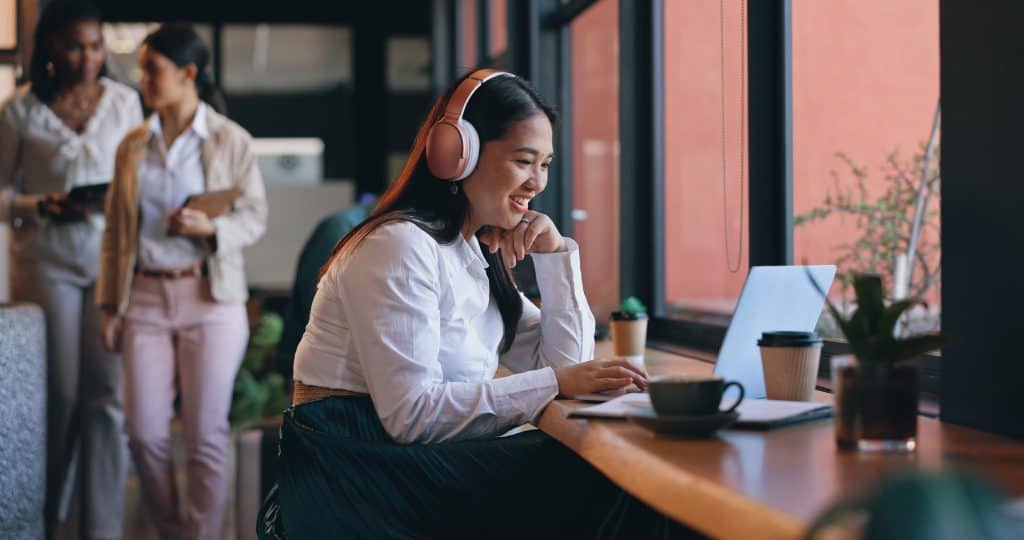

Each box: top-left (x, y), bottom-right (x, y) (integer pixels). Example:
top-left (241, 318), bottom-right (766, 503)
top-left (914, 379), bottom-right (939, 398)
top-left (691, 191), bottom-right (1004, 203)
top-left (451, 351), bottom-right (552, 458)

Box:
top-left (808, 273), bottom-right (947, 367)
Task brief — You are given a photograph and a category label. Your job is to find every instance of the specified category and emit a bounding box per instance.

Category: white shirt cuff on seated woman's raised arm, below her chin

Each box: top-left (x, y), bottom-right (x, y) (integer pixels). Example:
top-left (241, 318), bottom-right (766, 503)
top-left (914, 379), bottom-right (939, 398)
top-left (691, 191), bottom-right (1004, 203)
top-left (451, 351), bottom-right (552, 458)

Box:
top-left (530, 238), bottom-right (589, 311)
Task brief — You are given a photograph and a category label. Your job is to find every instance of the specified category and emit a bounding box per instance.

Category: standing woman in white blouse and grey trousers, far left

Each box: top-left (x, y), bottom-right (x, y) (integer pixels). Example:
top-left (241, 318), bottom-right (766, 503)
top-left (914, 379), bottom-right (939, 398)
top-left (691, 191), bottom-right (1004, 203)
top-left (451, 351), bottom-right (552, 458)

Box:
top-left (0, 0), bottom-right (142, 538)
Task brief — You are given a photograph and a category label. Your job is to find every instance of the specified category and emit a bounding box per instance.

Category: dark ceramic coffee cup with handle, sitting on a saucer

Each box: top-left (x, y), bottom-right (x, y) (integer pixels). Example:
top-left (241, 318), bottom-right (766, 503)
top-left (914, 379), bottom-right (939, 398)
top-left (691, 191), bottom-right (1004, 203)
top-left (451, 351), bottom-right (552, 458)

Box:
top-left (647, 375), bottom-right (743, 416)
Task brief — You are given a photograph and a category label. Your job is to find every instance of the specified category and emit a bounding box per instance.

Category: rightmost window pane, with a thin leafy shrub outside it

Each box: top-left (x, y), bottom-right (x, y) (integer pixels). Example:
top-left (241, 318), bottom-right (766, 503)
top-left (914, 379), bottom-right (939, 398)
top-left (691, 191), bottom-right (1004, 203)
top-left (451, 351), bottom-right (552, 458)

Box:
top-left (793, 0), bottom-right (941, 336)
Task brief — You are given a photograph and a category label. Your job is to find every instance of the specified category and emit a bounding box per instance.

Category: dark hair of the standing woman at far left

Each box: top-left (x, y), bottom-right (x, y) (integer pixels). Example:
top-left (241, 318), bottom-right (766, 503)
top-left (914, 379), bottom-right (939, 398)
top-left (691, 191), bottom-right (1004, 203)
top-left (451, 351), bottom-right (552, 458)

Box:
top-left (29, 0), bottom-right (106, 103)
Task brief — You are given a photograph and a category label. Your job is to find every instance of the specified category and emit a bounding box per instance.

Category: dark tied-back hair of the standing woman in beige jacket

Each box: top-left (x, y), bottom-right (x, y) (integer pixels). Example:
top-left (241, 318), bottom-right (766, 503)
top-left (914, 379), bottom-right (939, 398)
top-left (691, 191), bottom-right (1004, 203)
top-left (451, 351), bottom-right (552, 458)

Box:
top-left (142, 23), bottom-right (227, 115)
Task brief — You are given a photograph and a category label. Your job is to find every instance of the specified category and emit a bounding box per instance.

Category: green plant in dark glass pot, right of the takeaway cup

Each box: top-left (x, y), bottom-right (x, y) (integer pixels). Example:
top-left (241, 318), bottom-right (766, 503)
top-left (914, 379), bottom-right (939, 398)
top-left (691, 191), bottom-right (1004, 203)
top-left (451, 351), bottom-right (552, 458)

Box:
top-left (811, 274), bottom-right (945, 452)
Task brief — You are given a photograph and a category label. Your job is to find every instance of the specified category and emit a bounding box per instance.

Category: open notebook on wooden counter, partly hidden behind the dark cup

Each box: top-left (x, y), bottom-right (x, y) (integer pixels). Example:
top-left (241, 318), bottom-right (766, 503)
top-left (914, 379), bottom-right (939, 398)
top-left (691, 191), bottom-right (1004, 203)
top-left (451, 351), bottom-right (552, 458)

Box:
top-left (569, 392), bottom-right (833, 429)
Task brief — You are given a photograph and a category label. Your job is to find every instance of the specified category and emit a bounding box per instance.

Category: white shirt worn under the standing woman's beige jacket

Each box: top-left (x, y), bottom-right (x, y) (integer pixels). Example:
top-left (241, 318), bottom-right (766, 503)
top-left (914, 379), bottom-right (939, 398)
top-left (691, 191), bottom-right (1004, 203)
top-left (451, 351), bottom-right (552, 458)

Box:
top-left (138, 101), bottom-right (210, 268)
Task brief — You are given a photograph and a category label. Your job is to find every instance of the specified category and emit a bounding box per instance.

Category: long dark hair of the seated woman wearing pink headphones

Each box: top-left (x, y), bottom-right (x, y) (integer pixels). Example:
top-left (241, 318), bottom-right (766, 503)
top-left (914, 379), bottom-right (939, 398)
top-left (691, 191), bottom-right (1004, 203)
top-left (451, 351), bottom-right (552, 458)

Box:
top-left (321, 76), bottom-right (558, 352)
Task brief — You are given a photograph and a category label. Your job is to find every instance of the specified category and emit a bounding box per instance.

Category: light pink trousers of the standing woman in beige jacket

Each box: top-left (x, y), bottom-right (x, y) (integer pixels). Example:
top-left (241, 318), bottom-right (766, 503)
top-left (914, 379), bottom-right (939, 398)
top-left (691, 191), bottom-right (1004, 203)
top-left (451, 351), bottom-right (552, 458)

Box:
top-left (123, 275), bottom-right (249, 539)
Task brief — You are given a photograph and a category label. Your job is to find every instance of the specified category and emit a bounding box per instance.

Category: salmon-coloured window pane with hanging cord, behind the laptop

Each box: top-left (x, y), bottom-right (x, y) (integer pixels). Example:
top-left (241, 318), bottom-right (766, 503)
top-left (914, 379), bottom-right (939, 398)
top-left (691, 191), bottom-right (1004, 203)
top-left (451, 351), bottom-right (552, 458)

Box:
top-left (662, 0), bottom-right (749, 323)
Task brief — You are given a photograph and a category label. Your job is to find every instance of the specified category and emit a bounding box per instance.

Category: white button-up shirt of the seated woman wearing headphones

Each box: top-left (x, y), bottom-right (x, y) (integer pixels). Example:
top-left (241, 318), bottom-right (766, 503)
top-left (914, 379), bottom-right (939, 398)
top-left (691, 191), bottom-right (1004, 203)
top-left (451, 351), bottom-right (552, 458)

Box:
top-left (295, 221), bottom-right (594, 443)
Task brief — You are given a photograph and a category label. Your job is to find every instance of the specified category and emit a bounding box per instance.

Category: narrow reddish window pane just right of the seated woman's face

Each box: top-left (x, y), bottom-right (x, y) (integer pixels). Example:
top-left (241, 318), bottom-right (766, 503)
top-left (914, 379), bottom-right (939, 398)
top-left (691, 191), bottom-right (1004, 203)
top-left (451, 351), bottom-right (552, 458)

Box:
top-left (569, 0), bottom-right (620, 325)
